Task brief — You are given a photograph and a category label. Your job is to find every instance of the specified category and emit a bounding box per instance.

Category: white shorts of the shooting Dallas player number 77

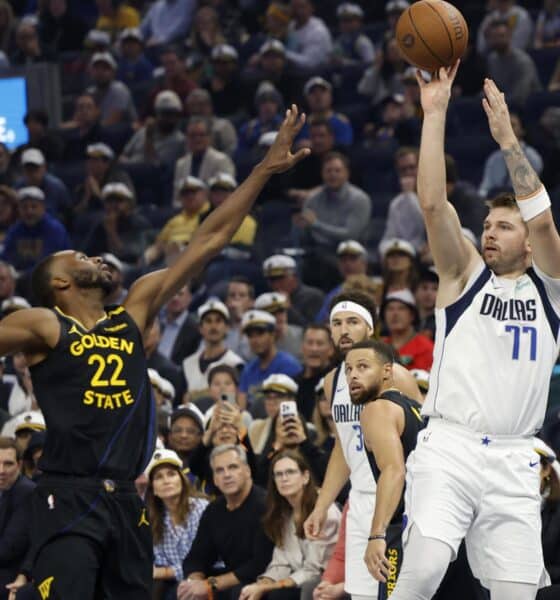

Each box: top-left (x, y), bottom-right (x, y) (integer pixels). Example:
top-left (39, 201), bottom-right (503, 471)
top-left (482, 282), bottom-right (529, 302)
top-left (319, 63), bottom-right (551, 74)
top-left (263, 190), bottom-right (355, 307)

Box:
top-left (403, 418), bottom-right (548, 587)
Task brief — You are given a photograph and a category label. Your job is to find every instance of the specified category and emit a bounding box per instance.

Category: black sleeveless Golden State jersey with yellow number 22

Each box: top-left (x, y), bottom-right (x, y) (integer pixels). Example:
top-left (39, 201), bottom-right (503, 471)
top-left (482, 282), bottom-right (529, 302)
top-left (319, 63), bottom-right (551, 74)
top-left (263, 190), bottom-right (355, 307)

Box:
top-left (31, 306), bottom-right (155, 480)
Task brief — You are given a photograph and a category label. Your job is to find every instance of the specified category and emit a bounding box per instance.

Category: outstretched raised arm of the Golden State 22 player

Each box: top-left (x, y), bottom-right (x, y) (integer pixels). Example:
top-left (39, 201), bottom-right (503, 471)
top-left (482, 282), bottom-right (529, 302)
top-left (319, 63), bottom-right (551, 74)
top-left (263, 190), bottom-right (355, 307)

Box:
top-left (124, 104), bottom-right (309, 328)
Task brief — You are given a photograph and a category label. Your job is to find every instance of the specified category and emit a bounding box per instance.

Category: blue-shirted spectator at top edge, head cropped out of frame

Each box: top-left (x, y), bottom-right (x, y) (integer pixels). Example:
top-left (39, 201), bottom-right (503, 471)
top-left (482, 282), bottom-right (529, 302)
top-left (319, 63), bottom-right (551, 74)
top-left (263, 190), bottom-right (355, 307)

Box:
top-left (140, 0), bottom-right (196, 46)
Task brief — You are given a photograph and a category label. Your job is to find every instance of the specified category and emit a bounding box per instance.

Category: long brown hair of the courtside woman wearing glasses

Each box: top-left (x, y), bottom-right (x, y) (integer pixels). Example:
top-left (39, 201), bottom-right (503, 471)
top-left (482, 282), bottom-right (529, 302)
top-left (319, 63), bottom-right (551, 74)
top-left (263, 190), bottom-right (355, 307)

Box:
top-left (263, 450), bottom-right (318, 548)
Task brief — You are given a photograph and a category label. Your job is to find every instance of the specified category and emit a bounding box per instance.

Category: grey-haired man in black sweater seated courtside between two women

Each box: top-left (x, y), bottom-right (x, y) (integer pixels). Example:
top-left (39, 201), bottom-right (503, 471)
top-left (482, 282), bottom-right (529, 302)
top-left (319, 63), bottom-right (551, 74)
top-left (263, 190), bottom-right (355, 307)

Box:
top-left (177, 445), bottom-right (272, 600)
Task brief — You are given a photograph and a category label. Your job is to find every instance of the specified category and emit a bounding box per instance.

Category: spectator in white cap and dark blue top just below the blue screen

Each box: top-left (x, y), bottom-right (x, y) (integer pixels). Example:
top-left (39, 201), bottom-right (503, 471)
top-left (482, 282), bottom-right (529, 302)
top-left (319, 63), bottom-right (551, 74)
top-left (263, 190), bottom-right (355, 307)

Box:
top-left (16, 148), bottom-right (71, 221)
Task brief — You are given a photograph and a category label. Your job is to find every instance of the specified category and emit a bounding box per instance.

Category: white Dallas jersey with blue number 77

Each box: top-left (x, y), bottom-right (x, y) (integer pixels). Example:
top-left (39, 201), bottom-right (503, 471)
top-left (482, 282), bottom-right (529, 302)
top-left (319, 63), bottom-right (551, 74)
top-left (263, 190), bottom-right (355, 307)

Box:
top-left (422, 264), bottom-right (560, 436)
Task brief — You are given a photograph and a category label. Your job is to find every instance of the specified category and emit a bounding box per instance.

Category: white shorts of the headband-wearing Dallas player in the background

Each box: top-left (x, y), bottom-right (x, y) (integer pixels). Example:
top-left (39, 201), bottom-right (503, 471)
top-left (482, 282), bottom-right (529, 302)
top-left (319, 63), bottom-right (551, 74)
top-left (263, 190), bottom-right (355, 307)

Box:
top-left (344, 489), bottom-right (379, 598)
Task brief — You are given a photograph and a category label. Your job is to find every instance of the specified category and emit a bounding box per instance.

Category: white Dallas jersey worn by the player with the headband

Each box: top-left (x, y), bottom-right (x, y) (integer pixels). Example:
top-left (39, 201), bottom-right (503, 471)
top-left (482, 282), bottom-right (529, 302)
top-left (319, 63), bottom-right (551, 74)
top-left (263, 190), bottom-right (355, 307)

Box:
top-left (331, 362), bottom-right (376, 494)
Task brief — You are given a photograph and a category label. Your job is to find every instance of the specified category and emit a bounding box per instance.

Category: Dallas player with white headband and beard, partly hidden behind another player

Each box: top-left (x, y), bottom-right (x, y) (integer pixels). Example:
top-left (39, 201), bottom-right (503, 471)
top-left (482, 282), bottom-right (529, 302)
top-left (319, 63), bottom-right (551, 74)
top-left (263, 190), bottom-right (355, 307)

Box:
top-left (304, 291), bottom-right (421, 598)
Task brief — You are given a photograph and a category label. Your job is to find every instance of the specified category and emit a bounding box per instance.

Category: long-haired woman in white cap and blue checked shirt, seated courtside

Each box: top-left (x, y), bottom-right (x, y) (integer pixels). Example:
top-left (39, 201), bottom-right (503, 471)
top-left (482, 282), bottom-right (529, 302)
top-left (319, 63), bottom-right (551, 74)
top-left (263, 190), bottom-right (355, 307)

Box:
top-left (146, 449), bottom-right (208, 589)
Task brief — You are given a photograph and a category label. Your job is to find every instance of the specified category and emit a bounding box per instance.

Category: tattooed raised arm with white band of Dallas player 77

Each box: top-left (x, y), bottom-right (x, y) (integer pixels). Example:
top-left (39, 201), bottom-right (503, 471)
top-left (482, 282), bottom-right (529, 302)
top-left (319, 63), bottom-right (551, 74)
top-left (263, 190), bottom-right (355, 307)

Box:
top-left (482, 79), bottom-right (560, 278)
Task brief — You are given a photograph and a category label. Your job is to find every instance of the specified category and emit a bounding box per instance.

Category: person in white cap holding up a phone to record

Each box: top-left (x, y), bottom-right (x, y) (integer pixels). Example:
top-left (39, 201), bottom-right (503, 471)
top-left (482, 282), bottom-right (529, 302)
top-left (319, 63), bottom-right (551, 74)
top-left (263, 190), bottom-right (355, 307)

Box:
top-left (249, 373), bottom-right (328, 485)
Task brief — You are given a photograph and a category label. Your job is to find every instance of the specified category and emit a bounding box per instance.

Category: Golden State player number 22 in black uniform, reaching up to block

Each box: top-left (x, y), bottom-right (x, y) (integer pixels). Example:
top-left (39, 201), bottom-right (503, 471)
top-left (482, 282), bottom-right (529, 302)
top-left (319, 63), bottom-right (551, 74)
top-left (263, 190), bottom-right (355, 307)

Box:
top-left (0, 106), bottom-right (309, 600)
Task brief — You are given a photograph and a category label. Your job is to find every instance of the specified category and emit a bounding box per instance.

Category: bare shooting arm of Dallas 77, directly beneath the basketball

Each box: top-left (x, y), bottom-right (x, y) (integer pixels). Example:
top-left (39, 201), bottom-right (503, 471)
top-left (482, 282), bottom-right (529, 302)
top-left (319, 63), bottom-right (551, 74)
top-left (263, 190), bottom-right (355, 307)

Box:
top-left (416, 62), bottom-right (481, 285)
